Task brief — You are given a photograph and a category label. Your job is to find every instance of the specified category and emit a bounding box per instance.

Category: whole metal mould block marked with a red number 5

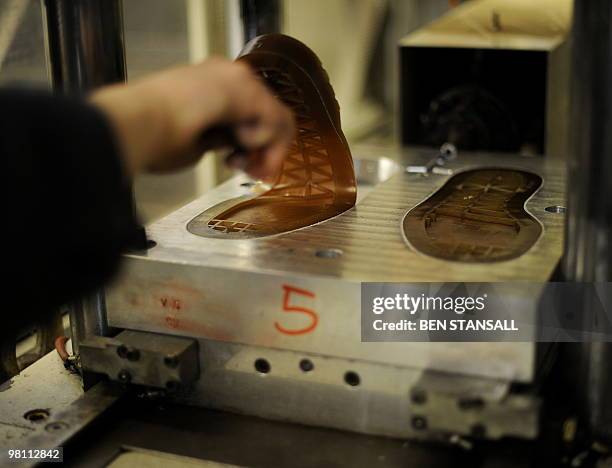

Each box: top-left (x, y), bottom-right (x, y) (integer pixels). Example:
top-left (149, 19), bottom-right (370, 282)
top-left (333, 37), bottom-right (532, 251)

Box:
top-left (107, 150), bottom-right (564, 381)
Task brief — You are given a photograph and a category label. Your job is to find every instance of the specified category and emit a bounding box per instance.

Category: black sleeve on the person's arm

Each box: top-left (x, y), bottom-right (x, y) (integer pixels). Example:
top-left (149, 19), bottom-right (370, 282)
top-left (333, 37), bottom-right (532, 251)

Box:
top-left (0, 90), bottom-right (141, 331)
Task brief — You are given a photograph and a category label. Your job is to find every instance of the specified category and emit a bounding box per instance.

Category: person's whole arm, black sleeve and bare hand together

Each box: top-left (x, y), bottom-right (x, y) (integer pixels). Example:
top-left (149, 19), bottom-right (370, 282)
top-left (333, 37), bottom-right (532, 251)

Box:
top-left (0, 59), bottom-right (294, 333)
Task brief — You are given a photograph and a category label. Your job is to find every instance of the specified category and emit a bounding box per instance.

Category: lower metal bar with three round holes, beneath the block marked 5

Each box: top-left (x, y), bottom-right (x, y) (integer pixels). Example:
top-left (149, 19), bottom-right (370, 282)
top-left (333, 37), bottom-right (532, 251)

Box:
top-left (171, 340), bottom-right (540, 439)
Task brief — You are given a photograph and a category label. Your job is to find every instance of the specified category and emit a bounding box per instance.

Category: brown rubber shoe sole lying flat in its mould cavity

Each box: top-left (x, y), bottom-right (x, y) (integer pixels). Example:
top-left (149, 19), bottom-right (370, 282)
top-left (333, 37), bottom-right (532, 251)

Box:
top-left (403, 169), bottom-right (542, 262)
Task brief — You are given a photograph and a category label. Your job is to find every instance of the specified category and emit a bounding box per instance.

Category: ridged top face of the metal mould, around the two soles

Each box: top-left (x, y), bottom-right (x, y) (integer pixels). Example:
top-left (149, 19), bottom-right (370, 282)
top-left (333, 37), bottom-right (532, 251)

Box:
top-left (116, 148), bottom-right (565, 282)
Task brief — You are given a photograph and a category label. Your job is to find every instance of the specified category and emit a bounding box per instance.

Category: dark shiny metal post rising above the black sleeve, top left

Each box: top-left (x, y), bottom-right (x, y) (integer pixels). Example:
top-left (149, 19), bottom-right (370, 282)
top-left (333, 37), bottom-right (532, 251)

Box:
top-left (43, 0), bottom-right (127, 92)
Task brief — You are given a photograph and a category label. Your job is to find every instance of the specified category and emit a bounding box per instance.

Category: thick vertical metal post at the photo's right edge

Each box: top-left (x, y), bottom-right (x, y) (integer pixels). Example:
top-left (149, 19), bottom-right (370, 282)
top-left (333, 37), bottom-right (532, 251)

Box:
top-left (563, 0), bottom-right (612, 439)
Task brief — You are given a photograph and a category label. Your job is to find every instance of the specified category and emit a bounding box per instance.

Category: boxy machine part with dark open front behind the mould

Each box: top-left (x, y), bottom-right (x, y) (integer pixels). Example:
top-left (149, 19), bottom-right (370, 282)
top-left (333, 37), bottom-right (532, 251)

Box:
top-left (400, 0), bottom-right (571, 157)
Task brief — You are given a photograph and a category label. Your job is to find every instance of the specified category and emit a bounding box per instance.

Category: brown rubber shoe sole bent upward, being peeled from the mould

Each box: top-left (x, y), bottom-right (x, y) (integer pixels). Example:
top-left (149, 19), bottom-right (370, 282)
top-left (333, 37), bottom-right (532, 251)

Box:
top-left (187, 34), bottom-right (357, 239)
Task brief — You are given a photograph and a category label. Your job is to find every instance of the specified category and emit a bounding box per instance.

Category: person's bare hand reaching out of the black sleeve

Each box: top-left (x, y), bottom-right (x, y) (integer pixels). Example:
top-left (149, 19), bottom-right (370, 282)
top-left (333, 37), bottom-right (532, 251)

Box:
top-left (90, 58), bottom-right (295, 178)
